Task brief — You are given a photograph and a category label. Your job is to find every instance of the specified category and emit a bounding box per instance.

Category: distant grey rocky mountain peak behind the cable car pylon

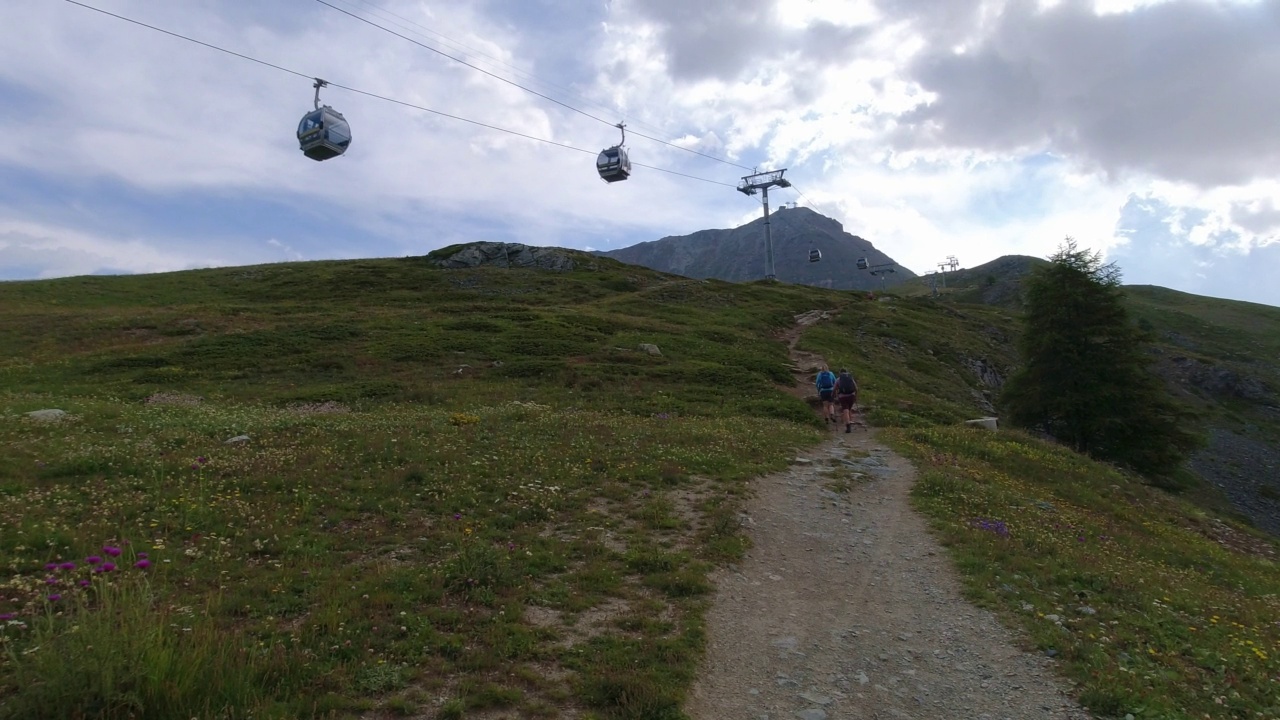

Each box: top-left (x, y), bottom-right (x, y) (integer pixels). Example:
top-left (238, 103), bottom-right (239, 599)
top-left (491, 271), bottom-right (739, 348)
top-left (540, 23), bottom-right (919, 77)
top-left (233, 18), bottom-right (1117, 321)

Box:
top-left (599, 208), bottom-right (916, 290)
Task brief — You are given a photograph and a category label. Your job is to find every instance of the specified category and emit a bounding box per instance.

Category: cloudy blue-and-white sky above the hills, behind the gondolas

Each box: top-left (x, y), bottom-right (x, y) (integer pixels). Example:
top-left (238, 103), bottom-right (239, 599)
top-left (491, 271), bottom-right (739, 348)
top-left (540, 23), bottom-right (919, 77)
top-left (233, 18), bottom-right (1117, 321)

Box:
top-left (0, 0), bottom-right (1280, 306)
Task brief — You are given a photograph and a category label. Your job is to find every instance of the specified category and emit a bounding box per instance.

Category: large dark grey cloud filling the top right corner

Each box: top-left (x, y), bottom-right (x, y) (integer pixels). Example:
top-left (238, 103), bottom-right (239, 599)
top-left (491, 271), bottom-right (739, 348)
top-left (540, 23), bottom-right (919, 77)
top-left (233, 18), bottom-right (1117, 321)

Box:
top-left (882, 0), bottom-right (1280, 187)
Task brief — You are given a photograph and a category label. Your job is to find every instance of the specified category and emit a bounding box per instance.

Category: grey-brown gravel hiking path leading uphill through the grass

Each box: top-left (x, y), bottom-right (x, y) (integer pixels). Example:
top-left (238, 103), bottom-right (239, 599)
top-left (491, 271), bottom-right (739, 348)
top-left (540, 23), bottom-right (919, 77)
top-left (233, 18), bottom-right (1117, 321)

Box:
top-left (686, 314), bottom-right (1089, 720)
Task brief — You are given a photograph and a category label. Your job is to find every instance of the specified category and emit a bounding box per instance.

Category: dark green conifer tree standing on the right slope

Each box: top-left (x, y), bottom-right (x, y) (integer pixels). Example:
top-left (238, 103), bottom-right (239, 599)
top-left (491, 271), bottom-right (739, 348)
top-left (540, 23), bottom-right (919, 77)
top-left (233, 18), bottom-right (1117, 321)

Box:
top-left (1001, 238), bottom-right (1197, 478)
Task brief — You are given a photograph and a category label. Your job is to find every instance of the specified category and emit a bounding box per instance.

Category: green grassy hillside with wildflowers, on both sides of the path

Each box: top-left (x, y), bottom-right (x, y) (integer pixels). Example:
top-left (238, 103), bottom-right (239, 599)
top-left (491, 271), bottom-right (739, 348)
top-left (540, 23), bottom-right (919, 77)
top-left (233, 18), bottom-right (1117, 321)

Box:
top-left (0, 255), bottom-right (1280, 719)
